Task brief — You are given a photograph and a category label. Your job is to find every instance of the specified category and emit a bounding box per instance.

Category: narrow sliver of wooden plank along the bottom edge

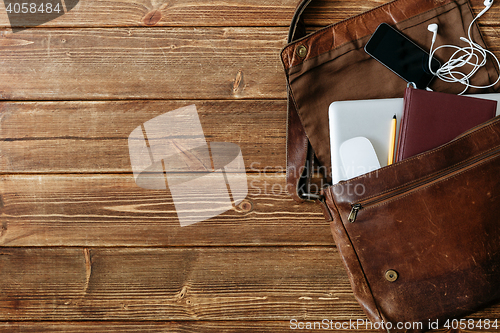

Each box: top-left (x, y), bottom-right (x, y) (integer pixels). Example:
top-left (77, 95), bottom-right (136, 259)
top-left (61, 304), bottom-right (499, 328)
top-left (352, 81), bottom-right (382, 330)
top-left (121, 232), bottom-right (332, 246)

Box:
top-left (0, 318), bottom-right (476, 333)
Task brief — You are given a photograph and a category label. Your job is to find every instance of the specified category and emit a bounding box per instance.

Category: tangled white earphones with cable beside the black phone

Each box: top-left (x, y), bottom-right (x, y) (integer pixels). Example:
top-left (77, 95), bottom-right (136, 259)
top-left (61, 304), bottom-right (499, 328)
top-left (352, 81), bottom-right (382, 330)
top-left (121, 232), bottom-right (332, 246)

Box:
top-left (427, 0), bottom-right (500, 95)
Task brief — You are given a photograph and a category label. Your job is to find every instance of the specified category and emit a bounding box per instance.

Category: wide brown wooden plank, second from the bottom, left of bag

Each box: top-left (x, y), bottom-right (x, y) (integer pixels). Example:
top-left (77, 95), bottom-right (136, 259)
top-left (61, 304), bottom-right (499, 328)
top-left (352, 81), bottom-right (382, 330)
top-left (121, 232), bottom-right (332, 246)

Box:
top-left (0, 247), bottom-right (364, 321)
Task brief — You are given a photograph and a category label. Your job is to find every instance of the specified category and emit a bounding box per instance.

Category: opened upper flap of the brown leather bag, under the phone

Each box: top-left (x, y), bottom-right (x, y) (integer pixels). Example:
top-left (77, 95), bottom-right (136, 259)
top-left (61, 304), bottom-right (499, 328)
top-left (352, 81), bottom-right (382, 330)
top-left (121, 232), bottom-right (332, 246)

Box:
top-left (282, 0), bottom-right (500, 193)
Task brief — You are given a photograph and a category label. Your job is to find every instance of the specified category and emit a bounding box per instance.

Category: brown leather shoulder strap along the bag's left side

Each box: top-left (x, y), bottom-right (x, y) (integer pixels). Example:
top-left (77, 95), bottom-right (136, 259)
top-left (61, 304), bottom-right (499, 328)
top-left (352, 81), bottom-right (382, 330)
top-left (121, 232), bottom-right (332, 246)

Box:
top-left (286, 0), bottom-right (321, 202)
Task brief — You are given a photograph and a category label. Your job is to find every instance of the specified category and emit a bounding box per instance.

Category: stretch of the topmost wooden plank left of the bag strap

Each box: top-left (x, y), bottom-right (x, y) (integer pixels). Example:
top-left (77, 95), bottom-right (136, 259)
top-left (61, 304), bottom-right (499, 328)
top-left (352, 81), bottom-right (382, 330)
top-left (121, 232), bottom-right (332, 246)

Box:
top-left (0, 0), bottom-right (298, 28)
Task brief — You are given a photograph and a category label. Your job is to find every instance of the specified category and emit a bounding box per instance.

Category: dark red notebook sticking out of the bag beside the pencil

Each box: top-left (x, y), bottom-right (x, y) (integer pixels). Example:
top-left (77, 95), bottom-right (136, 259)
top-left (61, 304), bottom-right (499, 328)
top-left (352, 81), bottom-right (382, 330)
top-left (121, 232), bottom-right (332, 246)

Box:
top-left (396, 88), bottom-right (497, 162)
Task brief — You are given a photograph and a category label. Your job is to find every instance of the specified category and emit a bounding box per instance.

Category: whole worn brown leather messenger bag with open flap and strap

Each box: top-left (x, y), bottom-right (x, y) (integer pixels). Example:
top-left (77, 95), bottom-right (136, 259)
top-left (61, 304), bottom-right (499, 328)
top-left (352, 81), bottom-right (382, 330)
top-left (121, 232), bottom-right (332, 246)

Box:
top-left (282, 0), bottom-right (500, 332)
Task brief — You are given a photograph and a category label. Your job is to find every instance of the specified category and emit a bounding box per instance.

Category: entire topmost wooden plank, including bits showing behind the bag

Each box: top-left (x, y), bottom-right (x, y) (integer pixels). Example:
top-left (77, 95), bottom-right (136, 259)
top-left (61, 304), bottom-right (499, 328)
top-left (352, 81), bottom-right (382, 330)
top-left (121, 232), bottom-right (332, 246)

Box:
top-left (0, 0), bottom-right (500, 29)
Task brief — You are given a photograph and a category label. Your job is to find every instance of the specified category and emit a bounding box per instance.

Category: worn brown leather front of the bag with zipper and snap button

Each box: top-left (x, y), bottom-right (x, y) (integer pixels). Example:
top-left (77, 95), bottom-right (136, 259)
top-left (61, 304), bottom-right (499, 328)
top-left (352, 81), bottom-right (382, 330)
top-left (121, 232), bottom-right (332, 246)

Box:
top-left (324, 117), bottom-right (500, 332)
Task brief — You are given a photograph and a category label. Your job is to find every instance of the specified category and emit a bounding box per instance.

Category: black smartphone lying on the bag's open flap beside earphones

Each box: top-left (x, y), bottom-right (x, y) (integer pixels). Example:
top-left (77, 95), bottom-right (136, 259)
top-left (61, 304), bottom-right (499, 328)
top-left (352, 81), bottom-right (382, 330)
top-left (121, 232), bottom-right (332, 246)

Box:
top-left (365, 23), bottom-right (441, 89)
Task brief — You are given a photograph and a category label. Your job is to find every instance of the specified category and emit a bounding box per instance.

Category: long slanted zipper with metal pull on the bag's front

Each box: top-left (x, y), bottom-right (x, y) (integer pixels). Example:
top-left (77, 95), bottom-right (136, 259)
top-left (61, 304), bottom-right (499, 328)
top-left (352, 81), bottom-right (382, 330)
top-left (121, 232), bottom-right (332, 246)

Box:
top-left (347, 148), bottom-right (500, 223)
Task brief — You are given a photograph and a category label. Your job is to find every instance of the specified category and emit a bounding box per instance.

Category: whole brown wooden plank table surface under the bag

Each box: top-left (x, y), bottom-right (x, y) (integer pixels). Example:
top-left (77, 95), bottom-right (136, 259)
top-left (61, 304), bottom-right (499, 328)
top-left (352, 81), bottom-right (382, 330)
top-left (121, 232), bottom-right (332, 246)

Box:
top-left (0, 0), bottom-right (500, 332)
